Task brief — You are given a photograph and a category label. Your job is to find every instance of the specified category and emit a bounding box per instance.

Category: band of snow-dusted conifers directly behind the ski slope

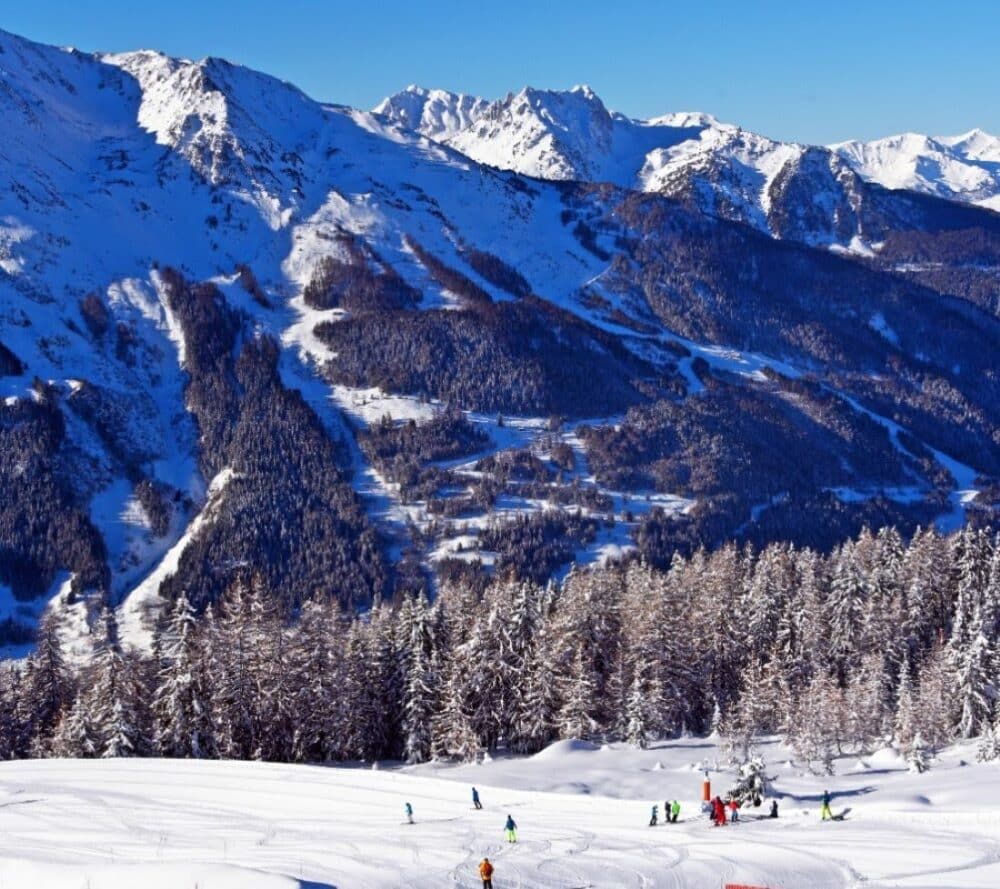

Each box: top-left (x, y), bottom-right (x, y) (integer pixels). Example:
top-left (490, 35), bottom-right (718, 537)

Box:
top-left (0, 528), bottom-right (1000, 770)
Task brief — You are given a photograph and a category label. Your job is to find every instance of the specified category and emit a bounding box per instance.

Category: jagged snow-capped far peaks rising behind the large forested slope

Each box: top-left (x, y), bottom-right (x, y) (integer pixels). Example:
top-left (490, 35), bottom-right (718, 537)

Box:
top-left (376, 86), bottom-right (1000, 243)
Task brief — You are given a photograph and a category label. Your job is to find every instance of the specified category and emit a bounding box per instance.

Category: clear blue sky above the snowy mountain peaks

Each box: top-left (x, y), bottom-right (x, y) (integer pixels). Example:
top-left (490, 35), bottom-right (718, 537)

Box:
top-left (0, 0), bottom-right (1000, 143)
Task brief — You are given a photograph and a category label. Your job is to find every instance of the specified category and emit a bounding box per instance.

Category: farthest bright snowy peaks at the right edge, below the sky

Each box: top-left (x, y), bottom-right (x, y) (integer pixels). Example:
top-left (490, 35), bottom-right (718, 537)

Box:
top-left (833, 130), bottom-right (1000, 210)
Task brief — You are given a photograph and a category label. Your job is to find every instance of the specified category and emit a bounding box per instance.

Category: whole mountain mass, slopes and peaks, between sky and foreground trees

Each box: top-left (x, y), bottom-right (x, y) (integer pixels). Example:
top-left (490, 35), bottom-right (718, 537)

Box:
top-left (0, 32), bottom-right (1000, 650)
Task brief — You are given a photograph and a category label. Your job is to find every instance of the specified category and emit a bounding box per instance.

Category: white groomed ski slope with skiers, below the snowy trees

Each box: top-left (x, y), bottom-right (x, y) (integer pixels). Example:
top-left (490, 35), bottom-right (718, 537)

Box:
top-left (0, 739), bottom-right (1000, 889)
